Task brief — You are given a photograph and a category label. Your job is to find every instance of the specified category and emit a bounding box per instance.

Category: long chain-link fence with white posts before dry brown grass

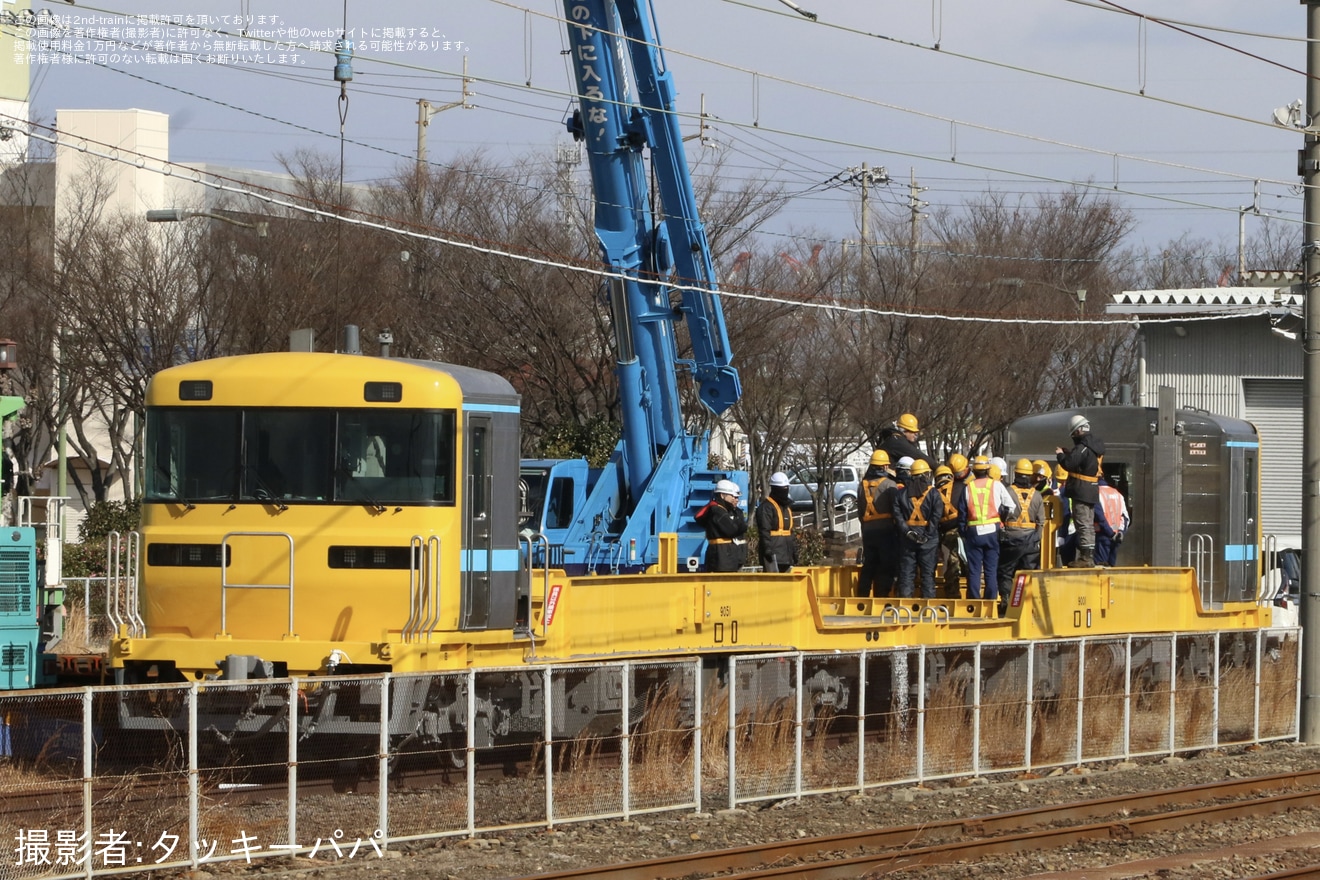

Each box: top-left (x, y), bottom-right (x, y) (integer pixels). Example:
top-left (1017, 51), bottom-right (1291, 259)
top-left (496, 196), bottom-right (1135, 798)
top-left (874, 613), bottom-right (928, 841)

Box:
top-left (0, 629), bottom-right (1300, 880)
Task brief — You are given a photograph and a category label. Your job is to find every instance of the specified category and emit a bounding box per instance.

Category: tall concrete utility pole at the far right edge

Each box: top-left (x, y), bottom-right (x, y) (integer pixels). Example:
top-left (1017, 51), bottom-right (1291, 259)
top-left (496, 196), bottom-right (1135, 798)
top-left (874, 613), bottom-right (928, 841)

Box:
top-left (1298, 0), bottom-right (1320, 743)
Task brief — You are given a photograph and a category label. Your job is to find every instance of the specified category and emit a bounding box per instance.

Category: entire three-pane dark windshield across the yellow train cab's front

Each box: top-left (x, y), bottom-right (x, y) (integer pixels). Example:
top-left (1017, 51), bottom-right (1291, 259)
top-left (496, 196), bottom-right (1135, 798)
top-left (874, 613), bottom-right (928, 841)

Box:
top-left (145, 408), bottom-right (455, 507)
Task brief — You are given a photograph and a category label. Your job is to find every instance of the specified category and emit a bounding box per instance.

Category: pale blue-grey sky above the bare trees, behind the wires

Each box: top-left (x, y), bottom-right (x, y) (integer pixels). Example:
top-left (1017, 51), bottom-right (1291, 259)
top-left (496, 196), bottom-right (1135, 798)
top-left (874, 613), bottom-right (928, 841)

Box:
top-left (20, 0), bottom-right (1305, 254)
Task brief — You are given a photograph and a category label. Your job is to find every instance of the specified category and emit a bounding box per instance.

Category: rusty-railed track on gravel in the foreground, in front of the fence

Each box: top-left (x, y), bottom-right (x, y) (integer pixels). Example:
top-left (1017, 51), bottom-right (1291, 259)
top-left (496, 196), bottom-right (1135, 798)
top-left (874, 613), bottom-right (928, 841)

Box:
top-left (506, 770), bottom-right (1320, 880)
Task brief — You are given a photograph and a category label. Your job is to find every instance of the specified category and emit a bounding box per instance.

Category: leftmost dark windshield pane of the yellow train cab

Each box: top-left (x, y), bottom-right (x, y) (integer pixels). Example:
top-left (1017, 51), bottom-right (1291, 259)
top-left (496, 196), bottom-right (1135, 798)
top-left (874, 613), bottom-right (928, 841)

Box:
top-left (145, 406), bottom-right (240, 504)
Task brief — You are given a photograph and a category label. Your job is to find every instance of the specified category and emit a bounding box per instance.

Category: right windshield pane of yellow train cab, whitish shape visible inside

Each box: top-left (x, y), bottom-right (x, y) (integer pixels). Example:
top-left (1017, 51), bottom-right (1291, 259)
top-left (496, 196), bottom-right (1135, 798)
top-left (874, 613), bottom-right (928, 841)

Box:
top-left (334, 409), bottom-right (455, 505)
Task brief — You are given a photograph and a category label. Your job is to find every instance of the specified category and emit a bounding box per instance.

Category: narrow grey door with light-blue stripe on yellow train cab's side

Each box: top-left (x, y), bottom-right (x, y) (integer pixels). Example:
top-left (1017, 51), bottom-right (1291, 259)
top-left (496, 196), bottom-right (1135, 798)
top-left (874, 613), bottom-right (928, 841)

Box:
top-left (459, 414), bottom-right (494, 629)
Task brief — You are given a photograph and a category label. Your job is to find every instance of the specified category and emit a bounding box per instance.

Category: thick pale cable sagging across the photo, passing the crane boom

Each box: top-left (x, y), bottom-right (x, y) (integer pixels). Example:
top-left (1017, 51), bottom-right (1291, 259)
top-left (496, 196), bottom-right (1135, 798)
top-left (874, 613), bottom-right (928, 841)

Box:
top-left (0, 112), bottom-right (1272, 333)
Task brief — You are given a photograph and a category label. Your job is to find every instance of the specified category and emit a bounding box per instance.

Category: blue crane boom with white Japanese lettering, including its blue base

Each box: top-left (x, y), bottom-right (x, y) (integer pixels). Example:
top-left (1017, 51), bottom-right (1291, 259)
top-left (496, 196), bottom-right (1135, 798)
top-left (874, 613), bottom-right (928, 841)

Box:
top-left (524, 0), bottom-right (747, 570)
